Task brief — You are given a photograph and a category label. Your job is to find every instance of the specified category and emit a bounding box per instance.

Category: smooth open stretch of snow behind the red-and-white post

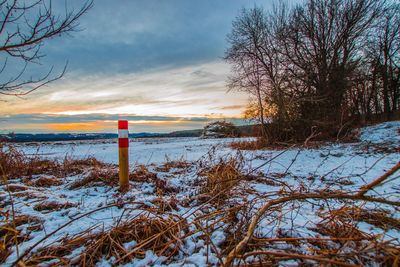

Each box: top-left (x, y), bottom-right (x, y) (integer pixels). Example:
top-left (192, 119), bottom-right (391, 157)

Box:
top-left (17, 137), bottom-right (247, 165)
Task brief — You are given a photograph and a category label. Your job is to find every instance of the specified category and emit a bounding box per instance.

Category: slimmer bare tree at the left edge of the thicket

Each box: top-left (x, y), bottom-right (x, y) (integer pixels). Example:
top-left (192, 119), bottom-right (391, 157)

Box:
top-left (225, 4), bottom-right (286, 141)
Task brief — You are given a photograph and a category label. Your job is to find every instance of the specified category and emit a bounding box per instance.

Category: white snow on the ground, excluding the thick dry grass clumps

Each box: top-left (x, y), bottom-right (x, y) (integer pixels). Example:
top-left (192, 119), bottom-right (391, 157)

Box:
top-left (0, 121), bottom-right (400, 266)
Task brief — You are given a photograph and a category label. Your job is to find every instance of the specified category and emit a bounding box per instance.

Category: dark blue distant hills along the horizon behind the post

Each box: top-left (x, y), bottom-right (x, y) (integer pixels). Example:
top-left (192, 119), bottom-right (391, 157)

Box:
top-left (0, 125), bottom-right (258, 143)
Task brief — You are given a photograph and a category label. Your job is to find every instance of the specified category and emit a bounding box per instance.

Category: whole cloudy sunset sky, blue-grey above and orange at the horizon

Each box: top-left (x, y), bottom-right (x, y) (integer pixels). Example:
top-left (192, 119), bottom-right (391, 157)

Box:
top-left (0, 0), bottom-right (272, 132)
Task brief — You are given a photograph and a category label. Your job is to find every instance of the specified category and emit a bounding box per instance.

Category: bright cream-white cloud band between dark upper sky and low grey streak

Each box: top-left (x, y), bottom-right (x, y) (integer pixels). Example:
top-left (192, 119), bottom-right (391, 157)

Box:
top-left (0, 61), bottom-right (247, 117)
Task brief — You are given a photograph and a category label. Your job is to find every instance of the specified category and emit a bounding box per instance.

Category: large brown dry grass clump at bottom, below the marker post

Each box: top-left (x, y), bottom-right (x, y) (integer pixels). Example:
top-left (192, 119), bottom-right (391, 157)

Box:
top-left (25, 215), bottom-right (188, 266)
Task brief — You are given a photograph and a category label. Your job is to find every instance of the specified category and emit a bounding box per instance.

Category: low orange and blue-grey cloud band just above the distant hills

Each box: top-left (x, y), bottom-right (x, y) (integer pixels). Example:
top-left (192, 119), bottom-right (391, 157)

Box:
top-left (0, 114), bottom-right (245, 133)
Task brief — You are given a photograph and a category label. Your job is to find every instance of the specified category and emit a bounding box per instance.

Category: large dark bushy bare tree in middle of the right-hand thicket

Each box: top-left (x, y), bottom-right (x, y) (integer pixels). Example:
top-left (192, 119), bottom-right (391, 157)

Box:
top-left (282, 0), bottom-right (384, 123)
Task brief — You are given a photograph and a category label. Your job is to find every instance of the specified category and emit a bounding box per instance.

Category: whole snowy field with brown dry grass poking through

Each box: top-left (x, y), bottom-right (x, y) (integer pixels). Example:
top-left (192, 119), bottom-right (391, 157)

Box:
top-left (0, 122), bottom-right (400, 266)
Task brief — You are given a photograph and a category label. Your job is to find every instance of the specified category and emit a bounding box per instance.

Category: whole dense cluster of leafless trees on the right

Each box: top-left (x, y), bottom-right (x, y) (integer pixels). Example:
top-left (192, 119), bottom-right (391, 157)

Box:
top-left (226, 0), bottom-right (400, 141)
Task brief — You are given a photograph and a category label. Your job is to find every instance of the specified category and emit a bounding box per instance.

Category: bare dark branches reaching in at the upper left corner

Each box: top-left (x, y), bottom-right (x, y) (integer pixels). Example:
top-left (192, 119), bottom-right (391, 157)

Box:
top-left (0, 0), bottom-right (93, 96)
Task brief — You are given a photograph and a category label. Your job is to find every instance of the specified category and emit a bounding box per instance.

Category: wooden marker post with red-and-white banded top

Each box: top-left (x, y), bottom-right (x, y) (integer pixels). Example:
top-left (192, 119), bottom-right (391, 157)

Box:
top-left (118, 120), bottom-right (129, 191)
